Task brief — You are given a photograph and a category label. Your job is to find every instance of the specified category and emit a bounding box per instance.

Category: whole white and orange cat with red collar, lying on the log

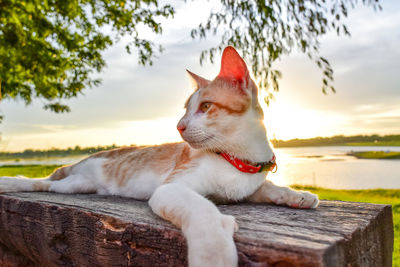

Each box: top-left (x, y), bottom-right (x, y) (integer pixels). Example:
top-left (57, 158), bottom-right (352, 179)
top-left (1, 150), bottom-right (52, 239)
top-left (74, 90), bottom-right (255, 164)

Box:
top-left (0, 46), bottom-right (318, 266)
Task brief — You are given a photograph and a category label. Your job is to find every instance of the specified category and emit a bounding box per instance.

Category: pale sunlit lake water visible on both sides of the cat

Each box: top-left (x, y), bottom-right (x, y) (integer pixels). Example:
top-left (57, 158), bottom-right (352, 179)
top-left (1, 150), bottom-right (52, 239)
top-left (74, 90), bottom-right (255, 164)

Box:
top-left (0, 146), bottom-right (400, 189)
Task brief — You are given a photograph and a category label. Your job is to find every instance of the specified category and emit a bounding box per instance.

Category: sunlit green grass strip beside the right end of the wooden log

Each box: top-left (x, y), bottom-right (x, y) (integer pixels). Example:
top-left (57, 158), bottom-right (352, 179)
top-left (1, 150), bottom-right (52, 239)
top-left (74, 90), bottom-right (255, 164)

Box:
top-left (292, 185), bottom-right (400, 266)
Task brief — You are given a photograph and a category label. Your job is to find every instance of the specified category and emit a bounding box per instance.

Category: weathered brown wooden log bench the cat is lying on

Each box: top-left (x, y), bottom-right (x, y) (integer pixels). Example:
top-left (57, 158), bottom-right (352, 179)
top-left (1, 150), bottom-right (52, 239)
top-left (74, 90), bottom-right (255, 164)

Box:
top-left (0, 193), bottom-right (393, 266)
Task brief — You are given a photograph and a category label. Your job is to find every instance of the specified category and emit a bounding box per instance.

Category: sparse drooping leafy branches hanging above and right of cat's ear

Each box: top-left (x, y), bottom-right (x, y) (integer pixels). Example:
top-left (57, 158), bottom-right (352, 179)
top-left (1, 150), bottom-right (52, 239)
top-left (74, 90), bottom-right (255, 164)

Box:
top-left (192, 0), bottom-right (381, 103)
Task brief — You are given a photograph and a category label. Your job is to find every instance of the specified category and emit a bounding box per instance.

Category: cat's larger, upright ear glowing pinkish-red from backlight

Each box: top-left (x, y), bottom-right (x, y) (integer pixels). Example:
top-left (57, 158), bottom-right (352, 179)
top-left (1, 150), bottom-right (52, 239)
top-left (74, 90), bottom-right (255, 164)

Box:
top-left (218, 46), bottom-right (250, 87)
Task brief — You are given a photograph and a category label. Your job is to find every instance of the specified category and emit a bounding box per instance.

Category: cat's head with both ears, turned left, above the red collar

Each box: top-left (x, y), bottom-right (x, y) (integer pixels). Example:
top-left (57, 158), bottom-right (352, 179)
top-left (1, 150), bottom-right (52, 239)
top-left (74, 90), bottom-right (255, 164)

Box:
top-left (177, 46), bottom-right (273, 160)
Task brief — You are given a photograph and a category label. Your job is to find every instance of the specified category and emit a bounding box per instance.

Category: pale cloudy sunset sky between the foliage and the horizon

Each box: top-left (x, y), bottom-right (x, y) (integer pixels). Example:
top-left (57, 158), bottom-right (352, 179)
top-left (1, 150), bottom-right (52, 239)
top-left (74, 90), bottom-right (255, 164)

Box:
top-left (0, 0), bottom-right (400, 151)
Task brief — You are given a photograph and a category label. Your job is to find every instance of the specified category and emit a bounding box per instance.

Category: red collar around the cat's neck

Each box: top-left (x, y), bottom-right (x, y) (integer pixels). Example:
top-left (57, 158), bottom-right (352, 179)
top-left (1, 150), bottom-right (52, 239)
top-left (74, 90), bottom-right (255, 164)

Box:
top-left (217, 152), bottom-right (278, 173)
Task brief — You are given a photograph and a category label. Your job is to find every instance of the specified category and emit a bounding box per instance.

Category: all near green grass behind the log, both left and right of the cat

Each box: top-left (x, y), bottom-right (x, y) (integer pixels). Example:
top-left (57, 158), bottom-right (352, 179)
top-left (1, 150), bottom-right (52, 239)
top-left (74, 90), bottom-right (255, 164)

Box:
top-left (0, 165), bottom-right (400, 266)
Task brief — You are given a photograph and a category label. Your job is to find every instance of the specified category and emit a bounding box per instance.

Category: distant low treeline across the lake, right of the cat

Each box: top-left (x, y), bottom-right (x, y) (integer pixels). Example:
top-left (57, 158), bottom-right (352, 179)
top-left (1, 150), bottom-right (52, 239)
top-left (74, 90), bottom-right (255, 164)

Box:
top-left (271, 135), bottom-right (400, 147)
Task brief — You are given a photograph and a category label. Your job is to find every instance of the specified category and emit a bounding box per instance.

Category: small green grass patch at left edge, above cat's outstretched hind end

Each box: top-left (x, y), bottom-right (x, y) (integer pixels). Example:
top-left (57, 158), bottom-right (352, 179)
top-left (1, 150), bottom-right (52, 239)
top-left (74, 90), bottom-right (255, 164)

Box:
top-left (0, 165), bottom-right (59, 178)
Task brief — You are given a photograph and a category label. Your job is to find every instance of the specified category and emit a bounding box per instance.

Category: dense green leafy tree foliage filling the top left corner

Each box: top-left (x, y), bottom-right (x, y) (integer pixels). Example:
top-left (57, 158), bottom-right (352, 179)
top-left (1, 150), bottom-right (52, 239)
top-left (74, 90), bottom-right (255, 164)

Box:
top-left (0, 0), bottom-right (174, 112)
